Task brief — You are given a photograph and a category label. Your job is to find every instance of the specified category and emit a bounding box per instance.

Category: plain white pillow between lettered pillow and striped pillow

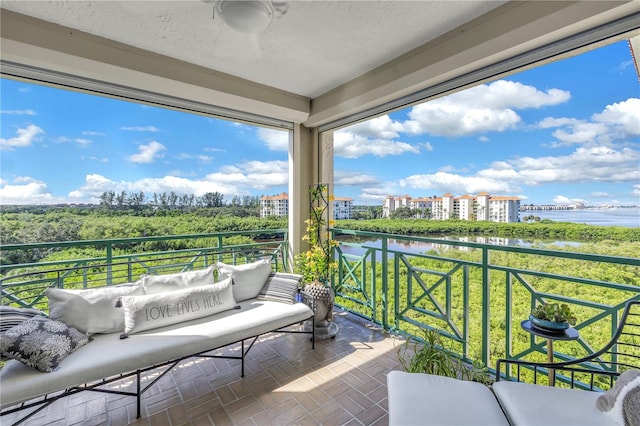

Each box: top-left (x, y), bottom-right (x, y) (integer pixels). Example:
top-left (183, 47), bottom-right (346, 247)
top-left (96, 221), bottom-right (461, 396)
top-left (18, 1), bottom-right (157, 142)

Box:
top-left (216, 259), bottom-right (271, 302)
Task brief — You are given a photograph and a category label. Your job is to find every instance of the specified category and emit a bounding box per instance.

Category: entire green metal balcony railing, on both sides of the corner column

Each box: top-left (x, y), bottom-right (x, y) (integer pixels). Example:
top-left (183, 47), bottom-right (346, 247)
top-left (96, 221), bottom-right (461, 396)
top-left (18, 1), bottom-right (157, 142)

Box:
top-left (0, 229), bottom-right (640, 380)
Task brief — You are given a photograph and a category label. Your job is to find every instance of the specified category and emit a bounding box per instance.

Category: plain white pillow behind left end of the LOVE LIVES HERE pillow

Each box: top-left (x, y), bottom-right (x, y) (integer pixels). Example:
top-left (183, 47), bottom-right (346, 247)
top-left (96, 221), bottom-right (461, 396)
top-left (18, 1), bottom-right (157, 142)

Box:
top-left (46, 282), bottom-right (144, 334)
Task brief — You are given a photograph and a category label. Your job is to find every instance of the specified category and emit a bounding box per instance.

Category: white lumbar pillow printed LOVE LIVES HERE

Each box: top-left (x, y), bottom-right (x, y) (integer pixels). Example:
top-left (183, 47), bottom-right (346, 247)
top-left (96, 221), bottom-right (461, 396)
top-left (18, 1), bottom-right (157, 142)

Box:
top-left (120, 278), bottom-right (236, 335)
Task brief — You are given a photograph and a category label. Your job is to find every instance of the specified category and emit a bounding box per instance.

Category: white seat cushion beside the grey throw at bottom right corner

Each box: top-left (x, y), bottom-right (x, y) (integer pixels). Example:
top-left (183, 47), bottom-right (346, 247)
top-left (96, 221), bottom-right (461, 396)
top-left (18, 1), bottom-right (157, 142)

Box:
top-left (493, 381), bottom-right (616, 426)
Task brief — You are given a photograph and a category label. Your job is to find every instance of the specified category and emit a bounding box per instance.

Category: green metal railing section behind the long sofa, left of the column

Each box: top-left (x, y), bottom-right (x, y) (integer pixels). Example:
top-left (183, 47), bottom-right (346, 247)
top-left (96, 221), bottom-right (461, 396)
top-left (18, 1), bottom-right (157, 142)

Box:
top-left (0, 229), bottom-right (288, 312)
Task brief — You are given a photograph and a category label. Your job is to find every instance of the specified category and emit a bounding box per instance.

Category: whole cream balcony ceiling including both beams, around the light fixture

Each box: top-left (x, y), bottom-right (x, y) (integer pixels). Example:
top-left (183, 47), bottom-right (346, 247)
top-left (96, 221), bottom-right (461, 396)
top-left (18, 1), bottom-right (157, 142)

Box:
top-left (1, 0), bottom-right (638, 125)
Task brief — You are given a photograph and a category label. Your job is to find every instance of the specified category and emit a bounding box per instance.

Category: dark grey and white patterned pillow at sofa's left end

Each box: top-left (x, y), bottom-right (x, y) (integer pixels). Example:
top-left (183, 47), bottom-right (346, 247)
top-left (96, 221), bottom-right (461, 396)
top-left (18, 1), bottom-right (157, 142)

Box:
top-left (0, 316), bottom-right (90, 373)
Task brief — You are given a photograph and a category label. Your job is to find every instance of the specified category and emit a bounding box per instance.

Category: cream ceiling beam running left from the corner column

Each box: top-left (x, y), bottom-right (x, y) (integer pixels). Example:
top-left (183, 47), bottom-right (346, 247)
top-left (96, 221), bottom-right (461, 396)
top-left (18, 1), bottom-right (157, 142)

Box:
top-left (0, 9), bottom-right (310, 123)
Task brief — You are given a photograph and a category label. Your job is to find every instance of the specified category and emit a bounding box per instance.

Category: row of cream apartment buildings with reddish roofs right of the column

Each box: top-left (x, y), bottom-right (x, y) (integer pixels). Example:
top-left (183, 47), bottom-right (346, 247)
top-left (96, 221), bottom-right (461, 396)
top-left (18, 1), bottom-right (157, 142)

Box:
top-left (382, 192), bottom-right (520, 222)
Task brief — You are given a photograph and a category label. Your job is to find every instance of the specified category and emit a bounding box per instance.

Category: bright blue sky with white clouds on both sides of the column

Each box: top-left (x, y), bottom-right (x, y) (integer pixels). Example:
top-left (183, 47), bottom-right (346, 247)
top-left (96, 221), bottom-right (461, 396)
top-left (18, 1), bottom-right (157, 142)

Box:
top-left (0, 41), bottom-right (640, 205)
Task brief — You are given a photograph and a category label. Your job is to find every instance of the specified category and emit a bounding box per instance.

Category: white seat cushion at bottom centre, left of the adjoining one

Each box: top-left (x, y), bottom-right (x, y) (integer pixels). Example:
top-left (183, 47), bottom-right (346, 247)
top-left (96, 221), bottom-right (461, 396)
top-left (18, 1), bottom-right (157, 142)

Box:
top-left (387, 371), bottom-right (509, 426)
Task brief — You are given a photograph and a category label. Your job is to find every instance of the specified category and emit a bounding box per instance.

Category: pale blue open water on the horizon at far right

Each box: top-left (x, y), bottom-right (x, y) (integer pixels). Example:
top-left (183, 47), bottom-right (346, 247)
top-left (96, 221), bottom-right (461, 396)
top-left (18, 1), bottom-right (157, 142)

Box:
top-left (520, 207), bottom-right (640, 228)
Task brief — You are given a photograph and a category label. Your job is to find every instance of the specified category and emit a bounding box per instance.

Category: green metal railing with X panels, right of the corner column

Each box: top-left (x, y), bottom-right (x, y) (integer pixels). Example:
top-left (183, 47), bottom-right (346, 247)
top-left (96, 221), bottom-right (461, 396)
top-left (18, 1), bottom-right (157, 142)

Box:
top-left (332, 229), bottom-right (640, 368)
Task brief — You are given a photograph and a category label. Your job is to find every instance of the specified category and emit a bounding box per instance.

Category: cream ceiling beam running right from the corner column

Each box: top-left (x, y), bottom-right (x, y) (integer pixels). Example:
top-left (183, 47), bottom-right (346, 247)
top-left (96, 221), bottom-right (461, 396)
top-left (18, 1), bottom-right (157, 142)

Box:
top-left (305, 0), bottom-right (640, 127)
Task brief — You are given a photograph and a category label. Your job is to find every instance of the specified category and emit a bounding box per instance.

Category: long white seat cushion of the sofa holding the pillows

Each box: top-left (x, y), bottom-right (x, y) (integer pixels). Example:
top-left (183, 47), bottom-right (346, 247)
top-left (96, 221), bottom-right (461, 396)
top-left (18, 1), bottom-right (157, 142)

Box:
top-left (0, 299), bottom-right (313, 408)
